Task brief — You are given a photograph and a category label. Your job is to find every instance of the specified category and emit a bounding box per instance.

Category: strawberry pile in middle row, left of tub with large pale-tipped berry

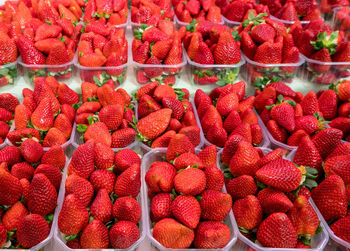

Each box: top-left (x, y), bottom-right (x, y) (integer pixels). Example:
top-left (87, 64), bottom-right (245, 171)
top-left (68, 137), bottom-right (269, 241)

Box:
top-left (75, 81), bottom-right (136, 148)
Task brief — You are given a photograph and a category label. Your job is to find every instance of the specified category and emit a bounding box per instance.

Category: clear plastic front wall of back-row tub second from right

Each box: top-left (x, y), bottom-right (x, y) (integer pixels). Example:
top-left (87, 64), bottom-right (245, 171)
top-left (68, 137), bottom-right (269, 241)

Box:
top-left (243, 55), bottom-right (305, 84)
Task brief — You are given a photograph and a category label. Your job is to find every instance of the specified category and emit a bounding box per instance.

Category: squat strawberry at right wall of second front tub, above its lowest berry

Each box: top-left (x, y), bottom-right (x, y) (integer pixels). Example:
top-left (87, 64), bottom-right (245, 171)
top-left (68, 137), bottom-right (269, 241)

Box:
top-left (113, 197), bottom-right (141, 224)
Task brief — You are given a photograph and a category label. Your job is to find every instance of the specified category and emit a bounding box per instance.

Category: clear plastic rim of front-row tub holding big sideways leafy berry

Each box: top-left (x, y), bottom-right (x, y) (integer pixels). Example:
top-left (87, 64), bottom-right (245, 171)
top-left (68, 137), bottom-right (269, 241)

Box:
top-left (218, 147), bottom-right (329, 251)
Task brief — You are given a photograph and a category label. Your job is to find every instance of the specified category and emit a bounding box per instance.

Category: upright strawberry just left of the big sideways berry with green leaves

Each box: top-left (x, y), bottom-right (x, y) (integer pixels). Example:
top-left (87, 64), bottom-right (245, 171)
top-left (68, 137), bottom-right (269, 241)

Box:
top-left (230, 141), bottom-right (260, 176)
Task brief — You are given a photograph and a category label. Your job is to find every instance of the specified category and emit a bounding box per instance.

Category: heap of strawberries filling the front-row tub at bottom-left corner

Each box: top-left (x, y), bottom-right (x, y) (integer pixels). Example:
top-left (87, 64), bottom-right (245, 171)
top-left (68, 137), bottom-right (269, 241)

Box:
top-left (0, 143), bottom-right (66, 249)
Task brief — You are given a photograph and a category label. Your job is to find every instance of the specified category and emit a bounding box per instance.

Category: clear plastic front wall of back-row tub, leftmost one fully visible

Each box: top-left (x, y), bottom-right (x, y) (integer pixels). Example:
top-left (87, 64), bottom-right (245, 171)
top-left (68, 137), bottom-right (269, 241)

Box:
top-left (18, 57), bottom-right (74, 85)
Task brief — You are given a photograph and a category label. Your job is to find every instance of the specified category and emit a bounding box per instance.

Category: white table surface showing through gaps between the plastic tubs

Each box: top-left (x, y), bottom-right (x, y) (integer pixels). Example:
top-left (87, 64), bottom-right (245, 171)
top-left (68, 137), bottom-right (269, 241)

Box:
top-left (0, 19), bottom-right (344, 251)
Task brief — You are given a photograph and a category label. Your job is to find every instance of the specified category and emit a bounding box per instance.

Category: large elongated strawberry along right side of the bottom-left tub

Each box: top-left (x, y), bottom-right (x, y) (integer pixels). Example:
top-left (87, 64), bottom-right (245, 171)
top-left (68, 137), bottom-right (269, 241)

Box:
top-left (28, 173), bottom-right (57, 216)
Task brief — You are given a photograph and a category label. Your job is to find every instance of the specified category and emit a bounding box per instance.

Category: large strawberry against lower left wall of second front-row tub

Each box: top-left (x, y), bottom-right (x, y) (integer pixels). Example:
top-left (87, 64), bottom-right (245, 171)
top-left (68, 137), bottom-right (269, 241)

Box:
top-left (58, 194), bottom-right (89, 235)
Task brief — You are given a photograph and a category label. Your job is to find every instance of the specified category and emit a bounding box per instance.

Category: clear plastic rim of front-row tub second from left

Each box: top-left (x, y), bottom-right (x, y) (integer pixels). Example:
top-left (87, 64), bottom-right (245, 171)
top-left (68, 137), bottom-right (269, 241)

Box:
top-left (53, 156), bottom-right (146, 251)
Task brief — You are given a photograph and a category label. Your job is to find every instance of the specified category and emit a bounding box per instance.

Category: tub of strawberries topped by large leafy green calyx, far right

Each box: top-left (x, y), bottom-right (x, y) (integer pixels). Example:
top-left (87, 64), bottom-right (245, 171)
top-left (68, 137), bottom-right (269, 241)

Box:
top-left (289, 20), bottom-right (350, 84)
